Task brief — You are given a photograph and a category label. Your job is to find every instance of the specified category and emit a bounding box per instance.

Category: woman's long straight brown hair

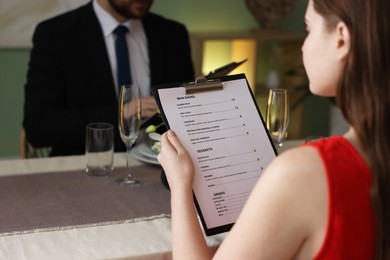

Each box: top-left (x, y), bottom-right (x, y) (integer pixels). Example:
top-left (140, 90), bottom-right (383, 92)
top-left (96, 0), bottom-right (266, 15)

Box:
top-left (313, 0), bottom-right (390, 259)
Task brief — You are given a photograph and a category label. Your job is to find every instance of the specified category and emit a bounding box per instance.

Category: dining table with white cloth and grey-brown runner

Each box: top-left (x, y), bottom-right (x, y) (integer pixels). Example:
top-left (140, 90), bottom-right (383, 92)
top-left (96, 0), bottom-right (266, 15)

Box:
top-left (0, 139), bottom-right (300, 259)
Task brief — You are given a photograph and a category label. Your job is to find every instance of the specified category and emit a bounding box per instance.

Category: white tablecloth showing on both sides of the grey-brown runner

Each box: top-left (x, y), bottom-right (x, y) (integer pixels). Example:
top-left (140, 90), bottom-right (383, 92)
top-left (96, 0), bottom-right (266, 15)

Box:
top-left (0, 140), bottom-right (302, 259)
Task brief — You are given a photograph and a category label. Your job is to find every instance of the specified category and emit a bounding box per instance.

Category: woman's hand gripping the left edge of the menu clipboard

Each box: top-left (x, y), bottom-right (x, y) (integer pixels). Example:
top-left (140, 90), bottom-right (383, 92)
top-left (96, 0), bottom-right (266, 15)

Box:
top-left (157, 130), bottom-right (194, 192)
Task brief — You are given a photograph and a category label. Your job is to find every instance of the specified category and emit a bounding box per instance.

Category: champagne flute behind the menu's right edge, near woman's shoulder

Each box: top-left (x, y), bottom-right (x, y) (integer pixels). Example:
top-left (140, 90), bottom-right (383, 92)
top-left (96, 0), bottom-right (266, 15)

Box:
top-left (266, 88), bottom-right (290, 148)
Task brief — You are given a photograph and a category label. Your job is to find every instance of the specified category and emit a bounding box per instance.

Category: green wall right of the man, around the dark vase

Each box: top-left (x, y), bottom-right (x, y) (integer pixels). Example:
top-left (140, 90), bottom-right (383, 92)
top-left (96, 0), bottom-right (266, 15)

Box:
top-left (152, 0), bottom-right (307, 32)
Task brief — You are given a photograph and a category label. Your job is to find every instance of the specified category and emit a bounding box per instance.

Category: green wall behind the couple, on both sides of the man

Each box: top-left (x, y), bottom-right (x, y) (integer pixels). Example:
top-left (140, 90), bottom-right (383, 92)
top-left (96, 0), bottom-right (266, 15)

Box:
top-left (0, 0), bottom-right (306, 159)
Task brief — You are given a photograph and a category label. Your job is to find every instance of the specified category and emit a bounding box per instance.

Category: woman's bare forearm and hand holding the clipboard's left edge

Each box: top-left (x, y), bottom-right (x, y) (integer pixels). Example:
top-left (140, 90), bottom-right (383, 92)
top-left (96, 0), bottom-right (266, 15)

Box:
top-left (157, 130), bottom-right (211, 259)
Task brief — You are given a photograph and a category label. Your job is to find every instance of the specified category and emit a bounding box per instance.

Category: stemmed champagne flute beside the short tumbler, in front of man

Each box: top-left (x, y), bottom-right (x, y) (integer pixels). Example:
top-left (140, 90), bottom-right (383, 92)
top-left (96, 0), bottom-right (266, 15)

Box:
top-left (116, 85), bottom-right (141, 187)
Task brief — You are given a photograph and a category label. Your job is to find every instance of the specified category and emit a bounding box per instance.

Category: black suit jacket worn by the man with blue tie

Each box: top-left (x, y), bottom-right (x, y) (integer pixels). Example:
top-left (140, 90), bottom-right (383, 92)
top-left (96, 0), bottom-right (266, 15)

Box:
top-left (23, 2), bottom-right (194, 155)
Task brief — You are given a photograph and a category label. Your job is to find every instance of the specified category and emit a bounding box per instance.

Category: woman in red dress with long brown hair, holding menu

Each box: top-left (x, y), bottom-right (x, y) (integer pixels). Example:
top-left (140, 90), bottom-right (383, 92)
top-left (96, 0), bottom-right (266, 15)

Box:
top-left (158, 0), bottom-right (390, 259)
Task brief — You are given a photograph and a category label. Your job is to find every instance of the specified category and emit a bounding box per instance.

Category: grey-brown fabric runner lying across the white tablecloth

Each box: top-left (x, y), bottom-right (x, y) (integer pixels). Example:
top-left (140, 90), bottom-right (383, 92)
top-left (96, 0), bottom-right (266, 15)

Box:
top-left (0, 166), bottom-right (170, 236)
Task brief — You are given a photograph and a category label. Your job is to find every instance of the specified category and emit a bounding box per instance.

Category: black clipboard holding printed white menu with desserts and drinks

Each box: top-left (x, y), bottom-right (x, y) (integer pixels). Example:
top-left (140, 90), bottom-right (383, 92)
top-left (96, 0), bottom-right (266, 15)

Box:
top-left (153, 74), bottom-right (277, 236)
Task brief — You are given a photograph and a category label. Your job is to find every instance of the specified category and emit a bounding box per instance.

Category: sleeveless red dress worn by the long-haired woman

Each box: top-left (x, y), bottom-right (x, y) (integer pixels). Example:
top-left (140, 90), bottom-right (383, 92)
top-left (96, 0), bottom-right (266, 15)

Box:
top-left (304, 136), bottom-right (375, 260)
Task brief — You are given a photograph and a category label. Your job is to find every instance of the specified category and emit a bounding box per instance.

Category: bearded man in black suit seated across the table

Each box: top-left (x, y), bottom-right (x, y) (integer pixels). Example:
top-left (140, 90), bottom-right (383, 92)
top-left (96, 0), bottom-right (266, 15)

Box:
top-left (23, 0), bottom-right (194, 156)
